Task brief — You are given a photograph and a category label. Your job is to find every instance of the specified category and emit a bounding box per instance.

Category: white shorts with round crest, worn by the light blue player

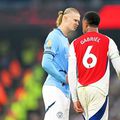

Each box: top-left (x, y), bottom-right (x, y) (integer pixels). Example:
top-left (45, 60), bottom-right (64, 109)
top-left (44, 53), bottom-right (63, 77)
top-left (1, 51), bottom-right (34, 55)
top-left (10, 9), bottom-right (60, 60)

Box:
top-left (42, 85), bottom-right (70, 120)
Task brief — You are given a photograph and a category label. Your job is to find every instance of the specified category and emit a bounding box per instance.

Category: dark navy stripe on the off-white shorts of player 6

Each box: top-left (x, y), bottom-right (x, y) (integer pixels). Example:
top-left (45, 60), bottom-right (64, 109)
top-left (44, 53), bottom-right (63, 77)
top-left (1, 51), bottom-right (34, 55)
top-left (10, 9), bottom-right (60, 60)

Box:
top-left (89, 96), bottom-right (108, 120)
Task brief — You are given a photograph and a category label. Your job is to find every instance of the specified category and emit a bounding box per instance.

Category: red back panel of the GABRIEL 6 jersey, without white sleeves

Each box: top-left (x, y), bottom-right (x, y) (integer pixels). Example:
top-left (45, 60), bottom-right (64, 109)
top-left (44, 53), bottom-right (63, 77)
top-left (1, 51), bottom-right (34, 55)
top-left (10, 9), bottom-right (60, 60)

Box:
top-left (73, 32), bottom-right (109, 86)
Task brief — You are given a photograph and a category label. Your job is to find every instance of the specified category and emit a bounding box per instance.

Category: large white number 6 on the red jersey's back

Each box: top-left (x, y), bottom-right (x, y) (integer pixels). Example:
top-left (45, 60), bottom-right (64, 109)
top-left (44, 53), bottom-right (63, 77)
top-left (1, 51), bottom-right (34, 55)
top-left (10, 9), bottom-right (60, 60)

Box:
top-left (83, 46), bottom-right (97, 68)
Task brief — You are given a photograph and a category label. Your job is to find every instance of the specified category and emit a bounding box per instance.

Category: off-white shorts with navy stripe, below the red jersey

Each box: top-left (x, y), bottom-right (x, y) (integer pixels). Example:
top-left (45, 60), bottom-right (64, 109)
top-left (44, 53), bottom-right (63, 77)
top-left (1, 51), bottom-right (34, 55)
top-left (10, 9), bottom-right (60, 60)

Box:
top-left (77, 86), bottom-right (109, 120)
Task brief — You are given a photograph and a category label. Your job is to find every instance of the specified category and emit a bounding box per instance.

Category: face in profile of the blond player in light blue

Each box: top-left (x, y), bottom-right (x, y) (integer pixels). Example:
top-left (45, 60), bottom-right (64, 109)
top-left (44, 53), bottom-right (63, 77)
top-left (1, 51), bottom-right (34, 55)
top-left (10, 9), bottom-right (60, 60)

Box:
top-left (66, 12), bottom-right (80, 31)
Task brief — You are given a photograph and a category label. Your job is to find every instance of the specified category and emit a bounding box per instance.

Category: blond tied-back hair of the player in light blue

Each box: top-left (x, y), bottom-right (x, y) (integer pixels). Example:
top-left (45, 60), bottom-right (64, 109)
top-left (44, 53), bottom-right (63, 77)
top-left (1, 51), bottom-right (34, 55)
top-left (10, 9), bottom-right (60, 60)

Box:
top-left (56, 8), bottom-right (80, 27)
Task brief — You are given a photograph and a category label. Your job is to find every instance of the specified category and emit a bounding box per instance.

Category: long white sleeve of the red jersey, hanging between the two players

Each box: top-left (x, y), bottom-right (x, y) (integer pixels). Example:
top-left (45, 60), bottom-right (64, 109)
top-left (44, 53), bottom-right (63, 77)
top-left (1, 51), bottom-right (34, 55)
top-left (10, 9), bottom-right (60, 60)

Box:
top-left (68, 43), bottom-right (78, 102)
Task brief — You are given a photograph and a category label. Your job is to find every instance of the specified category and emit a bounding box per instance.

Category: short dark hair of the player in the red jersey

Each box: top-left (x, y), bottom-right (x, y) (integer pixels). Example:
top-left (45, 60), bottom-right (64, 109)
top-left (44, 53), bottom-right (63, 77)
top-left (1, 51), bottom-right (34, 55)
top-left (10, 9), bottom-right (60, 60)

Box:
top-left (83, 11), bottom-right (100, 27)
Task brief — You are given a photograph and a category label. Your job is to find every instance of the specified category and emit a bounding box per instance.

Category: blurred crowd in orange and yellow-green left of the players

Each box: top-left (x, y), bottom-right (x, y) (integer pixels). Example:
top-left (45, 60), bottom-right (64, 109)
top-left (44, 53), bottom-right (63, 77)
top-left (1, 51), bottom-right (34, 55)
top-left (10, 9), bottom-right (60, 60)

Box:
top-left (0, 39), bottom-right (45, 120)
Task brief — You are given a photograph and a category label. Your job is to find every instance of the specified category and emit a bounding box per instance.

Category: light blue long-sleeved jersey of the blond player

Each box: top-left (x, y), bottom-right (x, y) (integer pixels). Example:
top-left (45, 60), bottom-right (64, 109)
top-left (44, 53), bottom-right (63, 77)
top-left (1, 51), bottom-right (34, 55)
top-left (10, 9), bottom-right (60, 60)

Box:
top-left (42, 28), bottom-right (70, 96)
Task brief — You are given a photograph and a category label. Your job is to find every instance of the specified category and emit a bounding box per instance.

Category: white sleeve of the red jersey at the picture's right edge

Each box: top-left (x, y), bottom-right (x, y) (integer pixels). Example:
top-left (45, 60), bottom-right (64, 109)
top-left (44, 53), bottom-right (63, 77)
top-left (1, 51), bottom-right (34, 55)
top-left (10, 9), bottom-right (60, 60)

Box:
top-left (108, 39), bottom-right (120, 79)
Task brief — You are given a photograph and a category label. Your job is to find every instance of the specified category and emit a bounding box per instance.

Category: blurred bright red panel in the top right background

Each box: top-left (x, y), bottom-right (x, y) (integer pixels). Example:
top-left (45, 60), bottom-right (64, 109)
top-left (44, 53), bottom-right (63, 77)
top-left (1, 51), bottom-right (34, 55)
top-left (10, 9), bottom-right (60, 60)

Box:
top-left (99, 5), bottom-right (120, 29)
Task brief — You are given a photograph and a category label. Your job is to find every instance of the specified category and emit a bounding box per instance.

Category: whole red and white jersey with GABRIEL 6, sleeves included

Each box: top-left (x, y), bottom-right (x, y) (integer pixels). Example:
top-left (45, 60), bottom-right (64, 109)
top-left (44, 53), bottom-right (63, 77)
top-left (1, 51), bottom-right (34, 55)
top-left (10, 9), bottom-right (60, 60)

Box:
top-left (68, 32), bottom-right (120, 101)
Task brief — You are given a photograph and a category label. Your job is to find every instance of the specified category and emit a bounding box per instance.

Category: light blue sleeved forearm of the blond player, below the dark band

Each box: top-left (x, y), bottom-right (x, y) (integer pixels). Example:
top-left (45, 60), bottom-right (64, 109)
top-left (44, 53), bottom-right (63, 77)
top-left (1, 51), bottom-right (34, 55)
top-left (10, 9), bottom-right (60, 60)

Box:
top-left (42, 54), bottom-right (66, 83)
